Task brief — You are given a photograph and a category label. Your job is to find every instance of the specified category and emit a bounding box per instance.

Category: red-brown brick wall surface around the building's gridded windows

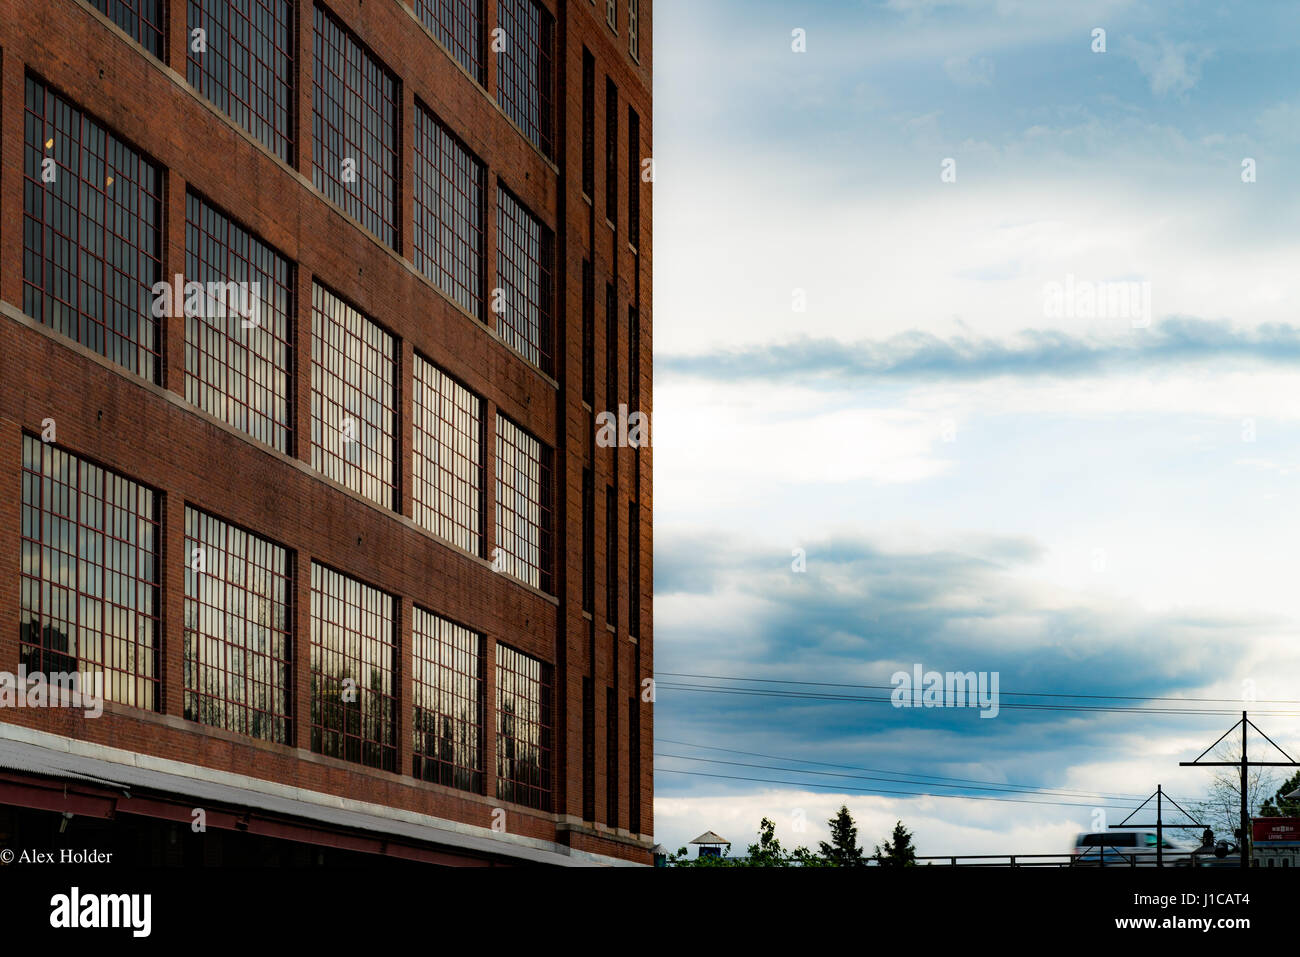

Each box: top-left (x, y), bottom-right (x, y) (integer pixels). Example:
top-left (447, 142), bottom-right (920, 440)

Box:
top-left (0, 0), bottom-right (654, 861)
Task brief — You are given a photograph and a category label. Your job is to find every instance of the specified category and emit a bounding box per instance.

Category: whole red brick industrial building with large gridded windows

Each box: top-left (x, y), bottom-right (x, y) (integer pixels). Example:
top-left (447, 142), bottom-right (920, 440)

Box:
top-left (0, 0), bottom-right (654, 865)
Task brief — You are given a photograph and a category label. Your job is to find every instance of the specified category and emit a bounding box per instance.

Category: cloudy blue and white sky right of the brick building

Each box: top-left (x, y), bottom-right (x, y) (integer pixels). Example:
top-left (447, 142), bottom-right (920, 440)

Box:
top-left (654, 0), bottom-right (1300, 854)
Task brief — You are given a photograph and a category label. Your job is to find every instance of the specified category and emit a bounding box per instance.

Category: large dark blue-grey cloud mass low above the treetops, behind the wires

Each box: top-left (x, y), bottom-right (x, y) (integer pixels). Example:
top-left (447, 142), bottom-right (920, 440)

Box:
top-left (655, 531), bottom-right (1300, 853)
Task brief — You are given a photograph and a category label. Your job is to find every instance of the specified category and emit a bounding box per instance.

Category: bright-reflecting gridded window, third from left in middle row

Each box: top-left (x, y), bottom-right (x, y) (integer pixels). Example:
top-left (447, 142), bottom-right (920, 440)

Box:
top-left (312, 283), bottom-right (398, 508)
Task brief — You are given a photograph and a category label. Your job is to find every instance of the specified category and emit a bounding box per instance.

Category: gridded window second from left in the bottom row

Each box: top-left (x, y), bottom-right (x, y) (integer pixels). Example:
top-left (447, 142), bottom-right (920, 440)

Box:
top-left (185, 506), bottom-right (293, 744)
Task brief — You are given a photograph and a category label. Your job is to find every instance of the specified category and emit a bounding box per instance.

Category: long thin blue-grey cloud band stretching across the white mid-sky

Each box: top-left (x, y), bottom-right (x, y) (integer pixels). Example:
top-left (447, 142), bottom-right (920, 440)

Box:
top-left (657, 319), bottom-right (1300, 386)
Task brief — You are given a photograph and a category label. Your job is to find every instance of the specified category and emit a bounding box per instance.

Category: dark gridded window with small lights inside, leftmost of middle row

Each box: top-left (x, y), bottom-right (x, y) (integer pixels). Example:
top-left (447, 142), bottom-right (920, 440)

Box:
top-left (22, 77), bottom-right (164, 382)
